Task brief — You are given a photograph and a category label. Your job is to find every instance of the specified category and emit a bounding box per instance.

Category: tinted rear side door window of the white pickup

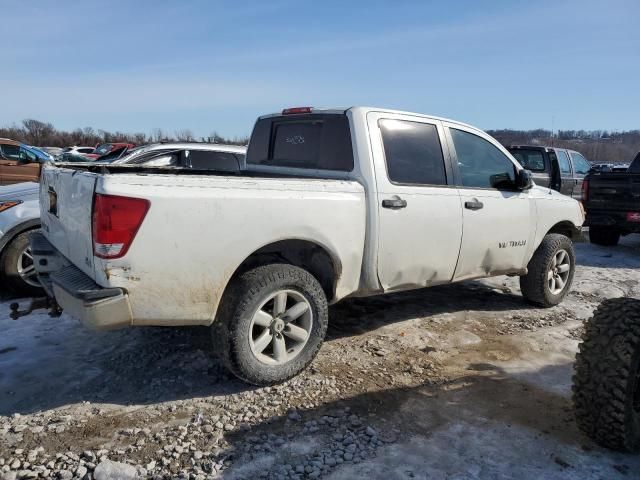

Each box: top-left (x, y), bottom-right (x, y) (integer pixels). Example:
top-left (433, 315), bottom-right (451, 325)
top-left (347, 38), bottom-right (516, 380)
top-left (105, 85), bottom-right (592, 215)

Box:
top-left (378, 119), bottom-right (447, 185)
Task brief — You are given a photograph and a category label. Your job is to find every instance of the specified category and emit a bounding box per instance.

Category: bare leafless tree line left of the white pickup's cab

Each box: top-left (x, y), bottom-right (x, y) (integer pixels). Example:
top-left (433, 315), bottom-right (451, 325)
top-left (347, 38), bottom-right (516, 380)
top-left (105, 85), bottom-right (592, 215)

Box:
top-left (0, 119), bottom-right (249, 147)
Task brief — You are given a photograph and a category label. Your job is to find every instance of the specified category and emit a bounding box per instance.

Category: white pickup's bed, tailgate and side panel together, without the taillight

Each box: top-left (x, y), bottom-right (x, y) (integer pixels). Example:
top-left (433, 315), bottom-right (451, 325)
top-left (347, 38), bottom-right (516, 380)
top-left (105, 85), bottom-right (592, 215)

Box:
top-left (40, 165), bottom-right (366, 325)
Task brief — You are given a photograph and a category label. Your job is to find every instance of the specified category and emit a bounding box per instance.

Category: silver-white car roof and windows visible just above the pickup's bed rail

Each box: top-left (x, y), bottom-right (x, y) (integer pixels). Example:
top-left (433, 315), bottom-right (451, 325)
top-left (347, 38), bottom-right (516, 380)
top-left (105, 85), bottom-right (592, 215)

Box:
top-left (109, 142), bottom-right (247, 170)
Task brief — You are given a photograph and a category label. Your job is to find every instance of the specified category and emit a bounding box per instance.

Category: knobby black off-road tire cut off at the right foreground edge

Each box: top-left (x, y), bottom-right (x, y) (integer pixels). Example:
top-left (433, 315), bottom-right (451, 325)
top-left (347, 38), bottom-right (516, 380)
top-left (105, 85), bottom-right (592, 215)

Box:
top-left (573, 298), bottom-right (640, 451)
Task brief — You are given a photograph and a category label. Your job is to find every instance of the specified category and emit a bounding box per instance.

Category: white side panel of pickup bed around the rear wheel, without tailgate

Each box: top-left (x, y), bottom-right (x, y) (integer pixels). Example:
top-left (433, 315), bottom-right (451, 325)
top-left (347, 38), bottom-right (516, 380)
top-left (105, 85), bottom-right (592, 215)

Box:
top-left (95, 175), bottom-right (366, 325)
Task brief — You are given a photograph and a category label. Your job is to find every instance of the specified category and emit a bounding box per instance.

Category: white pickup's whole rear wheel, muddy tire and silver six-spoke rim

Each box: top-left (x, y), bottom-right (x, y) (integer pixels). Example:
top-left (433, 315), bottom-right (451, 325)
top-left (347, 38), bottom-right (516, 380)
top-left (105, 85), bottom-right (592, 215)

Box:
top-left (212, 264), bottom-right (328, 385)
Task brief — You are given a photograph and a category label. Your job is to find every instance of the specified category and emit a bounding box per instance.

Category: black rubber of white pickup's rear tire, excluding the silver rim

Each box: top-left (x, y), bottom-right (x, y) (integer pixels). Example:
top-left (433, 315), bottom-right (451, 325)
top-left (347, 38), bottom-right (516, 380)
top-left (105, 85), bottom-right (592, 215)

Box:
top-left (211, 264), bottom-right (328, 386)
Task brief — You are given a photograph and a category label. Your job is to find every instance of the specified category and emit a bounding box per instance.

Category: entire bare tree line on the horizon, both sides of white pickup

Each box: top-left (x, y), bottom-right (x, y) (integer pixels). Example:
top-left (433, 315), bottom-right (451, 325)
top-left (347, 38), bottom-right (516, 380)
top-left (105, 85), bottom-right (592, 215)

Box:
top-left (0, 119), bottom-right (640, 163)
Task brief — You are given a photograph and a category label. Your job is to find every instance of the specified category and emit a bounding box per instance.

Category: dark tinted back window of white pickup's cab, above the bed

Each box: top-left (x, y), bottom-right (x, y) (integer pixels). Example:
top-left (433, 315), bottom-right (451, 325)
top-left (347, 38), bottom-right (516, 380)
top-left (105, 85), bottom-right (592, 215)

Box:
top-left (246, 113), bottom-right (354, 172)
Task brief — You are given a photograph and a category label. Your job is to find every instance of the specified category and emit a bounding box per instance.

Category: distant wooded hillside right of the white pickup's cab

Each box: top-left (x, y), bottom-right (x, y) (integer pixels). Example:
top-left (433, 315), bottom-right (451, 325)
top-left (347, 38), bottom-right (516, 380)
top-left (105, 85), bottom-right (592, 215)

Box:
top-left (488, 129), bottom-right (640, 163)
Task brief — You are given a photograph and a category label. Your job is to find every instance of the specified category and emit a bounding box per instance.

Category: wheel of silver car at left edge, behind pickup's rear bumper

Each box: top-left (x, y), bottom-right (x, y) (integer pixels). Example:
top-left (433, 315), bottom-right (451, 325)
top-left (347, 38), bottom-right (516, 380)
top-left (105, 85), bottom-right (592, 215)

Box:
top-left (0, 232), bottom-right (42, 295)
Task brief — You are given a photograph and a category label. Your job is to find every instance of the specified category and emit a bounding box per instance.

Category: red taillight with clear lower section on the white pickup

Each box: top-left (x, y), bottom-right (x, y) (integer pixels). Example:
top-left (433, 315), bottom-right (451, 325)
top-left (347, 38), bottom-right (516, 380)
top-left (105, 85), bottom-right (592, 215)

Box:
top-left (93, 193), bottom-right (151, 258)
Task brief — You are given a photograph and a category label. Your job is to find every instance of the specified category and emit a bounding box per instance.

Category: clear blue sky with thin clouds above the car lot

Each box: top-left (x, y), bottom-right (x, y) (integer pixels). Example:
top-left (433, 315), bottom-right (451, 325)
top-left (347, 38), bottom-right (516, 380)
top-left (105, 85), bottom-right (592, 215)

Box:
top-left (0, 0), bottom-right (640, 135)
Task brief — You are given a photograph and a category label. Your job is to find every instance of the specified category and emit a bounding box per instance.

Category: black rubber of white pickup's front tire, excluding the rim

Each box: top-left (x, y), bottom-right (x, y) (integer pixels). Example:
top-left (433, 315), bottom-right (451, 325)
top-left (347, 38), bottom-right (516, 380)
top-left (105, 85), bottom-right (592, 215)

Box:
top-left (520, 233), bottom-right (576, 307)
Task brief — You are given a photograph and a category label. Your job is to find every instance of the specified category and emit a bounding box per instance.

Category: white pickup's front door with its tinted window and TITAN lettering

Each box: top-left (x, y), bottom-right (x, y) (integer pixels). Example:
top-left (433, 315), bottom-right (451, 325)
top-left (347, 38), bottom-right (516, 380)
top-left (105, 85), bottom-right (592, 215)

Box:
top-left (445, 124), bottom-right (535, 280)
